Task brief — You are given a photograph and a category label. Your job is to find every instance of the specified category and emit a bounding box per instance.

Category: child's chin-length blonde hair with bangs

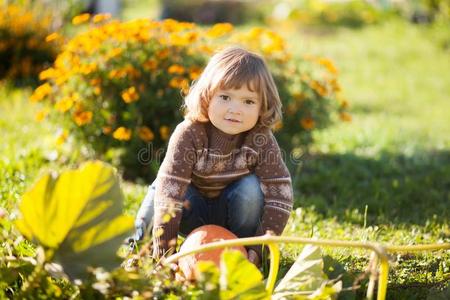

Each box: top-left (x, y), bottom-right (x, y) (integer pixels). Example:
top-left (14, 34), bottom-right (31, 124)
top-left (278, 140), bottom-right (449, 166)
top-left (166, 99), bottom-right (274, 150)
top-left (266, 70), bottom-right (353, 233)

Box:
top-left (183, 47), bottom-right (282, 127)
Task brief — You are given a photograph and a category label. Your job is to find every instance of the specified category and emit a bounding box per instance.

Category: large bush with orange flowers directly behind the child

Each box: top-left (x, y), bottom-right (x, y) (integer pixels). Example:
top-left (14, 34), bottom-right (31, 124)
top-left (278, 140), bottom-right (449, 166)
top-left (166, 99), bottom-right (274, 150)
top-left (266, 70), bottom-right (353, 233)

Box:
top-left (31, 14), bottom-right (348, 180)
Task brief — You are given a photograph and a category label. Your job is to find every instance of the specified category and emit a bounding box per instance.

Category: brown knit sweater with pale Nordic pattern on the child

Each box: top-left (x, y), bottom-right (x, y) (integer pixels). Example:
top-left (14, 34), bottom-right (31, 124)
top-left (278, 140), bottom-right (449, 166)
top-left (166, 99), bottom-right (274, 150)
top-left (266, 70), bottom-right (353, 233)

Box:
top-left (153, 120), bottom-right (293, 257)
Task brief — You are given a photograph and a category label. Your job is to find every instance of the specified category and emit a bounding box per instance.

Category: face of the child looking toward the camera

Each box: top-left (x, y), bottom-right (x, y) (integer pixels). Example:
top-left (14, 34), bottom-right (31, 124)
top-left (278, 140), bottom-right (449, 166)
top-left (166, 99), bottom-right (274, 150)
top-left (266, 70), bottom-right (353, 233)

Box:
top-left (208, 84), bottom-right (261, 134)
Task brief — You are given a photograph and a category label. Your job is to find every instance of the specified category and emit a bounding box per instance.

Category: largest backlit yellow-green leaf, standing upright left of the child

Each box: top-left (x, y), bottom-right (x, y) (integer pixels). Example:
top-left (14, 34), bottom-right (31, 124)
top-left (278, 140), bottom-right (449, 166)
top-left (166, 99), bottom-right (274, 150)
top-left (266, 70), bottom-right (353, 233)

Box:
top-left (16, 161), bottom-right (133, 278)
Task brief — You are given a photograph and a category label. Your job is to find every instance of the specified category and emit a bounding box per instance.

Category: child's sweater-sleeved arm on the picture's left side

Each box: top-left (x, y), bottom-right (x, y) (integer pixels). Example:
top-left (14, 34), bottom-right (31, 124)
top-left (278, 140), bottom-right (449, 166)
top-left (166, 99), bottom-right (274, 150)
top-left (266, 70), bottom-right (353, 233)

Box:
top-left (153, 121), bottom-right (196, 258)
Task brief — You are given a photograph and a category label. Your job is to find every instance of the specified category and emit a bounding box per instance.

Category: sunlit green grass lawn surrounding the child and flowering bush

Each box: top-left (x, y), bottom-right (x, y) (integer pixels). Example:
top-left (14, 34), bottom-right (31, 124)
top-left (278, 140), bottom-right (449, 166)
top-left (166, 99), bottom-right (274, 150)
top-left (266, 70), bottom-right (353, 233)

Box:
top-left (0, 17), bottom-right (450, 299)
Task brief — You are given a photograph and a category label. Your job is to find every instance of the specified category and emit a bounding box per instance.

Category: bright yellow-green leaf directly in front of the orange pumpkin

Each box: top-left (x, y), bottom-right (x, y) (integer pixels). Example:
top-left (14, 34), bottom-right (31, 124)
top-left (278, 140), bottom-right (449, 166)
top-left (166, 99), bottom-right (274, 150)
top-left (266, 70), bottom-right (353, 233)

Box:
top-left (220, 250), bottom-right (269, 299)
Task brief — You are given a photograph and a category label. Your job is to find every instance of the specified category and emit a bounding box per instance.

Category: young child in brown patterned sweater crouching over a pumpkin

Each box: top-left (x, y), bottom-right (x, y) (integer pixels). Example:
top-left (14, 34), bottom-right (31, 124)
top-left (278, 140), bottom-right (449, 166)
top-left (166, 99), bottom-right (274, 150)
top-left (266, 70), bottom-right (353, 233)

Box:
top-left (134, 47), bottom-right (293, 265)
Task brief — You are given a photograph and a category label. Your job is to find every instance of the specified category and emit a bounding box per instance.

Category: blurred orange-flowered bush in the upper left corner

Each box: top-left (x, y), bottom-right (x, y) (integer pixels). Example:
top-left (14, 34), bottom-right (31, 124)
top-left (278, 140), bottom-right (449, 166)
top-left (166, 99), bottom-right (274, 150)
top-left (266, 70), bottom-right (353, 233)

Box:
top-left (0, 1), bottom-right (60, 84)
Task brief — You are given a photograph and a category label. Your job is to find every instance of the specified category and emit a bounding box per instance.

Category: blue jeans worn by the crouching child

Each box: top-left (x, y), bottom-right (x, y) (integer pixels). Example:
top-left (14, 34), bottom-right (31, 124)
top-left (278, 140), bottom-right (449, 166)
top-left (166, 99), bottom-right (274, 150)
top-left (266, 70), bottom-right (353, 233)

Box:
top-left (135, 174), bottom-right (264, 240)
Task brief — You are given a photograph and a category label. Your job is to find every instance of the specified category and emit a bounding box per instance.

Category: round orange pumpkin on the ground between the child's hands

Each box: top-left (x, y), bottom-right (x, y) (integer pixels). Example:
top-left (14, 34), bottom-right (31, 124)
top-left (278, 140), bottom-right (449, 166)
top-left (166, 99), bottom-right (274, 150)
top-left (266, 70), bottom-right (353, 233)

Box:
top-left (178, 225), bottom-right (247, 280)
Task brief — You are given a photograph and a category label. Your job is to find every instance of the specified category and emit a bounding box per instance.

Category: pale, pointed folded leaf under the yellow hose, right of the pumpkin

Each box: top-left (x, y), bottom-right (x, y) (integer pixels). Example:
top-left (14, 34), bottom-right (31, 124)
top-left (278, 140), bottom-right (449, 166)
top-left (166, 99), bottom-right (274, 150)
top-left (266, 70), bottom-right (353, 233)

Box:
top-left (272, 245), bottom-right (342, 299)
